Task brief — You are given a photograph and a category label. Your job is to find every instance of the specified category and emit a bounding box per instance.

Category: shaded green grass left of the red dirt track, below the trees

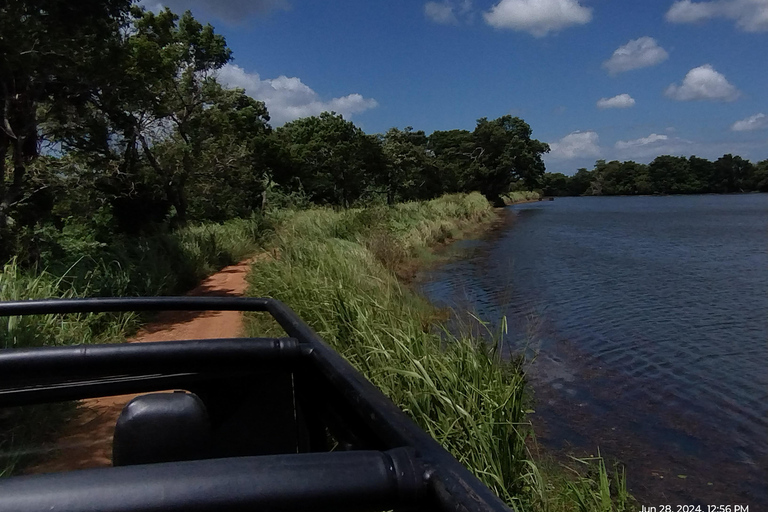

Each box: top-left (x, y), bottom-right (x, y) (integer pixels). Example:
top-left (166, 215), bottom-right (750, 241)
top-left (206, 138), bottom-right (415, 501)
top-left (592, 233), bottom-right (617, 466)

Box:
top-left (0, 218), bottom-right (266, 476)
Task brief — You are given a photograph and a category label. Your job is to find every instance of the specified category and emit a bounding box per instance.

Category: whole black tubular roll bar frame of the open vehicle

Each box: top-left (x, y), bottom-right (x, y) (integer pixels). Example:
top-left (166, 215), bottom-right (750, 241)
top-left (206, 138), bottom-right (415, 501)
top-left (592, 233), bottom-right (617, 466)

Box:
top-left (0, 297), bottom-right (509, 512)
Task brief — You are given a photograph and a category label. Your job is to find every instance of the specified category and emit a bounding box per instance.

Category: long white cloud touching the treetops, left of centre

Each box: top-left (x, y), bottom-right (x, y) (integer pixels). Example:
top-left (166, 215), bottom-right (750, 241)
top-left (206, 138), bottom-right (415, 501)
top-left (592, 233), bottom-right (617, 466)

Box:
top-left (218, 64), bottom-right (378, 126)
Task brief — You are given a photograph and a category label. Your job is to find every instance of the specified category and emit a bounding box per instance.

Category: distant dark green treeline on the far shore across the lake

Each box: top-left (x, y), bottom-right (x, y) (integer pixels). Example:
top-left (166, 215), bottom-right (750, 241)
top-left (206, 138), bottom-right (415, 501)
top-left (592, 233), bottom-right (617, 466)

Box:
top-left (542, 155), bottom-right (768, 196)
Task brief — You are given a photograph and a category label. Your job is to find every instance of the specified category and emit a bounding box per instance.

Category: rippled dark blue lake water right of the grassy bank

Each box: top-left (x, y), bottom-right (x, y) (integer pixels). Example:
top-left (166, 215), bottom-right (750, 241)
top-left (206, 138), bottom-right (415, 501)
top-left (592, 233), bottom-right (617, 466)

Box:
top-left (418, 194), bottom-right (768, 511)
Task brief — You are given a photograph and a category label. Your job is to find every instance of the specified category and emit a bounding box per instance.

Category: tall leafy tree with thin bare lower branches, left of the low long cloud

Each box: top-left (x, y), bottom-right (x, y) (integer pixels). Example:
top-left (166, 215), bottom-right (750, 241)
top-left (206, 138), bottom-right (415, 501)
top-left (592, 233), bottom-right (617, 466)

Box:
top-left (48, 6), bottom-right (231, 231)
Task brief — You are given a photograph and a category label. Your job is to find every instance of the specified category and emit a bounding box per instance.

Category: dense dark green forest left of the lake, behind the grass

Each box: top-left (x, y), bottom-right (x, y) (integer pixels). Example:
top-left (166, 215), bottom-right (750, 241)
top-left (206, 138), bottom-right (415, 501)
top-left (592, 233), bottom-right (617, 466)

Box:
top-left (0, 0), bottom-right (549, 267)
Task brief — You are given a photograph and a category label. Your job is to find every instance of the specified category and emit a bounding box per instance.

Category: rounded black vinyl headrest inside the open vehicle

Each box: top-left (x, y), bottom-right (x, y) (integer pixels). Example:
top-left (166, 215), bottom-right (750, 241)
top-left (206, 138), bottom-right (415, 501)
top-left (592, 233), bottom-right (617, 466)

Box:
top-left (112, 392), bottom-right (211, 466)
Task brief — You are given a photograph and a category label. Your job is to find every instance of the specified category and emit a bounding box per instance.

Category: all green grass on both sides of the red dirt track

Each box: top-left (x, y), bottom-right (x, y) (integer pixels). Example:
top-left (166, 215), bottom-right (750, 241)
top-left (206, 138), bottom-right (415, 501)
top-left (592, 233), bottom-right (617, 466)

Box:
top-left (0, 194), bottom-right (631, 512)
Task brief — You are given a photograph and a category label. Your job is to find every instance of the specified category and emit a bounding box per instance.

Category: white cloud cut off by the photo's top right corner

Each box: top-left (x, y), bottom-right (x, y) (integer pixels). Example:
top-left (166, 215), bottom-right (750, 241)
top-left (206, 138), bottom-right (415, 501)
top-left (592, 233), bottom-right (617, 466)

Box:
top-left (666, 0), bottom-right (768, 32)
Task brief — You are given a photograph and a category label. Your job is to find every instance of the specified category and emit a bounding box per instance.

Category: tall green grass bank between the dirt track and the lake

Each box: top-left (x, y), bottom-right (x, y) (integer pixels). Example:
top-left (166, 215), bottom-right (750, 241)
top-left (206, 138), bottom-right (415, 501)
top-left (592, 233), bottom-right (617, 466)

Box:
top-left (249, 194), bottom-right (626, 512)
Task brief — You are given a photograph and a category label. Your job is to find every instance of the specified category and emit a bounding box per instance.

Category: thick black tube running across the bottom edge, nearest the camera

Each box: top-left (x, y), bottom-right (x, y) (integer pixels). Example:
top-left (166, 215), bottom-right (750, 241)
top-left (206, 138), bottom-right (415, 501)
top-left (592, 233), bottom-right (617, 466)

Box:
top-left (0, 450), bottom-right (425, 512)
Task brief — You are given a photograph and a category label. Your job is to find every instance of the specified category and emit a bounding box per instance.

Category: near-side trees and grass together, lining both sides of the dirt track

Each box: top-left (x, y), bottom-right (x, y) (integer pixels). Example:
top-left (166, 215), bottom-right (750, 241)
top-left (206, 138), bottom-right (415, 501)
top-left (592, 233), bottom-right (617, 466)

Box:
top-left (0, 0), bottom-right (640, 511)
